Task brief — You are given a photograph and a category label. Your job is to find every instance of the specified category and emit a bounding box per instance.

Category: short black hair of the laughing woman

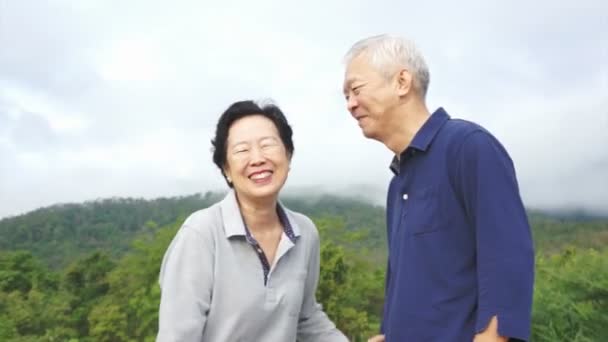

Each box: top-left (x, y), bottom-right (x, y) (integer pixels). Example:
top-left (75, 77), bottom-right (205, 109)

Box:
top-left (211, 100), bottom-right (294, 187)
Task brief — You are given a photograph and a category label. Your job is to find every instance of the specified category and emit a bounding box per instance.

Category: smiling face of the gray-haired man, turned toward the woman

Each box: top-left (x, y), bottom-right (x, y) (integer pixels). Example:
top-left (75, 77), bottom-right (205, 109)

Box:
top-left (343, 54), bottom-right (399, 141)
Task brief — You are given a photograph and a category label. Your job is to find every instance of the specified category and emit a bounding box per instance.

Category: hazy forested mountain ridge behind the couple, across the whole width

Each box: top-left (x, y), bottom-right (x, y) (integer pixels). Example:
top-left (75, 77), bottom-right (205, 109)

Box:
top-left (0, 191), bottom-right (608, 268)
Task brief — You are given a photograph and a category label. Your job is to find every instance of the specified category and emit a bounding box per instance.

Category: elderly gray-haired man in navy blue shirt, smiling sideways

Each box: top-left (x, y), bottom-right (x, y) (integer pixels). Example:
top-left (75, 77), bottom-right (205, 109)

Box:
top-left (343, 35), bottom-right (534, 342)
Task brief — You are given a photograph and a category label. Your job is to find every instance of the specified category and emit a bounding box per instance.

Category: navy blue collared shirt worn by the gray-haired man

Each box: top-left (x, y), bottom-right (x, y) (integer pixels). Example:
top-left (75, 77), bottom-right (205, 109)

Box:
top-left (381, 108), bottom-right (534, 342)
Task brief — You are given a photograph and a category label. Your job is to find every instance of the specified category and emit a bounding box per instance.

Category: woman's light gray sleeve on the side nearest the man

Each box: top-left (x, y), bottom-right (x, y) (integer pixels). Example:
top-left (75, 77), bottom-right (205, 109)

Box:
top-left (297, 229), bottom-right (348, 342)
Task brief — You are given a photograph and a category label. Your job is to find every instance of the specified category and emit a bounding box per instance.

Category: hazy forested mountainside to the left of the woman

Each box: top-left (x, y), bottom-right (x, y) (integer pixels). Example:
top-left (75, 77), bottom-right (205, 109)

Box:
top-left (0, 192), bottom-right (220, 269)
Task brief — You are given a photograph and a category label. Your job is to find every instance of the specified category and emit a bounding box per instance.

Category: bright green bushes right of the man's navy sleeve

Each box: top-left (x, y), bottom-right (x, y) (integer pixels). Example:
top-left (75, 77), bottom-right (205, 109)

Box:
top-left (533, 248), bottom-right (608, 342)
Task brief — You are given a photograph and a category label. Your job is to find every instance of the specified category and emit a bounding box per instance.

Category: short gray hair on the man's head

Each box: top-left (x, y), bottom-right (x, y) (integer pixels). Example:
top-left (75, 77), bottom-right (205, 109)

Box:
top-left (344, 34), bottom-right (430, 99)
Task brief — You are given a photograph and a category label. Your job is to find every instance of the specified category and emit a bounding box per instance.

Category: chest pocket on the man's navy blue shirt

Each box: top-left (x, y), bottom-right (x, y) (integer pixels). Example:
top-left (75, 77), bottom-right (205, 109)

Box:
top-left (401, 186), bottom-right (445, 235)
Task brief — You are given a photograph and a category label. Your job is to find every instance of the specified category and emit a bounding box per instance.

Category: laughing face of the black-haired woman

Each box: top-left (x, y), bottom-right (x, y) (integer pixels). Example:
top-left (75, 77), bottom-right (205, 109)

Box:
top-left (224, 115), bottom-right (290, 200)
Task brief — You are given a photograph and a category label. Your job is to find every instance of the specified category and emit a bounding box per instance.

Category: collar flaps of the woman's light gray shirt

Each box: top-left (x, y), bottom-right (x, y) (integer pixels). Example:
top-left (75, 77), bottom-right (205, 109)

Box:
top-left (220, 189), bottom-right (300, 242)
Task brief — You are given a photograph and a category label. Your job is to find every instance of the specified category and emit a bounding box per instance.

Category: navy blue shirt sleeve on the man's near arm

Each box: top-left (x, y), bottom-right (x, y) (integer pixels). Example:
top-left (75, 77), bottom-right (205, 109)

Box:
top-left (456, 131), bottom-right (534, 340)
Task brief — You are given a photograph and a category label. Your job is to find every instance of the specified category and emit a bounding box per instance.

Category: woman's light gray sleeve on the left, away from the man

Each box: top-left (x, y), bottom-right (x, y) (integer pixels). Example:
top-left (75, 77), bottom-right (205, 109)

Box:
top-left (156, 223), bottom-right (214, 342)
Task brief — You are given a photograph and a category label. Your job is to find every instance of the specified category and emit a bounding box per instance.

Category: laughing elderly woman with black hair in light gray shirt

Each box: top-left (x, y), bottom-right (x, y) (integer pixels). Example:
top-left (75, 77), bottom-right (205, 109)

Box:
top-left (157, 101), bottom-right (347, 342)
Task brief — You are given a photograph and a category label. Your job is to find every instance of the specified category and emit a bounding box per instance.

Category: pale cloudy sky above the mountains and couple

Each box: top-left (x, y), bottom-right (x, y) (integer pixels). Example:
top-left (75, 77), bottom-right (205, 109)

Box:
top-left (0, 0), bottom-right (608, 217)
